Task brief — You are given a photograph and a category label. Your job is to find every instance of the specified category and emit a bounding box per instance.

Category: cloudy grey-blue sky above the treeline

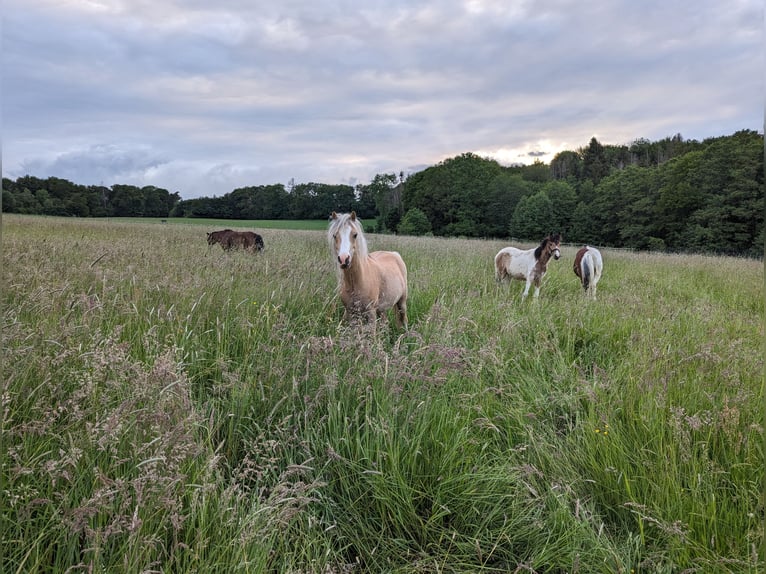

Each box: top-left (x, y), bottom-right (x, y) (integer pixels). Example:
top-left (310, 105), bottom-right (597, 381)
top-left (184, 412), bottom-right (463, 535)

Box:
top-left (2, 0), bottom-right (766, 199)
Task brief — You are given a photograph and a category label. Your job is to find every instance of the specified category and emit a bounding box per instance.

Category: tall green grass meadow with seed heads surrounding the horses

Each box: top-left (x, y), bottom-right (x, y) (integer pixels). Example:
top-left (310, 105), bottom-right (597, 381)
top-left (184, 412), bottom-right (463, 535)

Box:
top-left (0, 215), bottom-right (766, 574)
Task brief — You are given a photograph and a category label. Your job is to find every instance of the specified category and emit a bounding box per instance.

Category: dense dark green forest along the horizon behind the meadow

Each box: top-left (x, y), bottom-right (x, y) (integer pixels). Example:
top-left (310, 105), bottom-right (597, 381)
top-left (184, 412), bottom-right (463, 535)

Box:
top-left (2, 130), bottom-right (765, 256)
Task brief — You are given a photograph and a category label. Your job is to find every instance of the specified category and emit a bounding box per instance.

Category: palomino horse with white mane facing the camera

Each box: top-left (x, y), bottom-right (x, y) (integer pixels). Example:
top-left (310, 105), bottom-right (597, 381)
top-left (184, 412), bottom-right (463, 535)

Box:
top-left (327, 211), bottom-right (407, 329)
